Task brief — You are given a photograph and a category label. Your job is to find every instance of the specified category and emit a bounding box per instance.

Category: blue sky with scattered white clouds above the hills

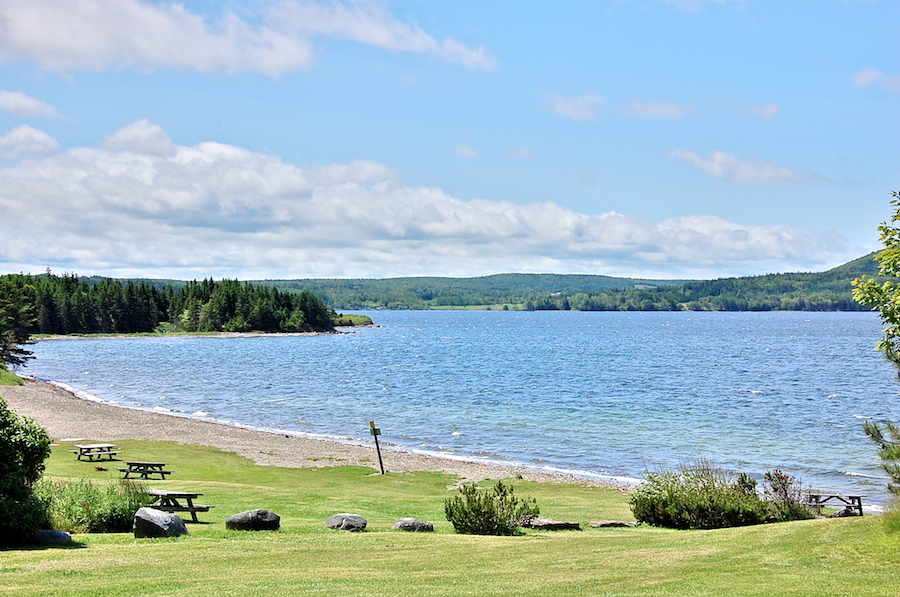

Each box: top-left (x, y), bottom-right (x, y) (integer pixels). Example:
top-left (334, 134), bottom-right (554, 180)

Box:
top-left (0, 0), bottom-right (900, 280)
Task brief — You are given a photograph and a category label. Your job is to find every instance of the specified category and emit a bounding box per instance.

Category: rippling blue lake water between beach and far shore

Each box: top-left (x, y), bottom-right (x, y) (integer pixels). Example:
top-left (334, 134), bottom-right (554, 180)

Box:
top-left (25, 311), bottom-right (900, 503)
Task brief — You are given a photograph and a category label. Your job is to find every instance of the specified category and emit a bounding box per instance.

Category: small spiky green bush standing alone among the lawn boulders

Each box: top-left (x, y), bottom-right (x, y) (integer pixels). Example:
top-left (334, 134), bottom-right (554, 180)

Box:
top-left (444, 481), bottom-right (540, 535)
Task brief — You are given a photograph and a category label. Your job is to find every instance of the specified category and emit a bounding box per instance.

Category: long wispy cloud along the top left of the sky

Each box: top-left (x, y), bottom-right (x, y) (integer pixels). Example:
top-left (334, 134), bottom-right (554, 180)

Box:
top-left (0, 0), bottom-right (496, 76)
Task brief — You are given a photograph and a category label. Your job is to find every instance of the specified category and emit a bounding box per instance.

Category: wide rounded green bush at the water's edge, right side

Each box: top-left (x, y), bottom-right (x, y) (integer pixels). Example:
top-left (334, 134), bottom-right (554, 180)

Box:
top-left (631, 463), bottom-right (769, 529)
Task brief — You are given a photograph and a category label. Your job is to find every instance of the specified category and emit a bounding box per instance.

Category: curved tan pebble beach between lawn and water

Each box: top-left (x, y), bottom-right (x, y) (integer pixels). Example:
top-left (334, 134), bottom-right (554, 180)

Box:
top-left (0, 378), bottom-right (634, 491)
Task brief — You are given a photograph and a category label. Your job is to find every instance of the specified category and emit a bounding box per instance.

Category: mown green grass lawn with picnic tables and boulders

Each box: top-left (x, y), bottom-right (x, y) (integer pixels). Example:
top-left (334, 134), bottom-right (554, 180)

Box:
top-left (0, 441), bottom-right (900, 597)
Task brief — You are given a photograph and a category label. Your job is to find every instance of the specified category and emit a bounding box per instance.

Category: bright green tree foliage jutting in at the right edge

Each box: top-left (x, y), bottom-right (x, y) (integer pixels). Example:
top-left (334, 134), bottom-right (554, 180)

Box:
top-left (853, 191), bottom-right (900, 495)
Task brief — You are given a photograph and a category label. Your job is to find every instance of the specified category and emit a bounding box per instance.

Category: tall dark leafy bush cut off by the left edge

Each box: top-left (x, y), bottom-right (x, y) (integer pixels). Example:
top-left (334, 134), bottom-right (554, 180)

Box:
top-left (0, 398), bottom-right (50, 545)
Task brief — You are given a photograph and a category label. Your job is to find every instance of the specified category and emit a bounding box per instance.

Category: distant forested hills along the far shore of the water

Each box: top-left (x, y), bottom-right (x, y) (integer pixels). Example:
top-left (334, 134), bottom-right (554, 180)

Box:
top-left (72, 253), bottom-right (878, 311)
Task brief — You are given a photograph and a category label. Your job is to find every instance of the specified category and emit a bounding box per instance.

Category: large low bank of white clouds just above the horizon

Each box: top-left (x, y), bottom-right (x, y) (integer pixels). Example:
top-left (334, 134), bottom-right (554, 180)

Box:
top-left (0, 121), bottom-right (848, 279)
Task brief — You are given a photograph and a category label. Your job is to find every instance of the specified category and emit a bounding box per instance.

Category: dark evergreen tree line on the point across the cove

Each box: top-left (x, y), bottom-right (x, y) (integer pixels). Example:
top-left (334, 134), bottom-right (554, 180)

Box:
top-left (0, 272), bottom-right (336, 334)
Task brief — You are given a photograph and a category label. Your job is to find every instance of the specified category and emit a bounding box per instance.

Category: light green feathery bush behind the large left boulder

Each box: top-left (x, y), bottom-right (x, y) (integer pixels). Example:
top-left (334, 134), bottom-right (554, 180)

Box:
top-left (35, 479), bottom-right (154, 533)
